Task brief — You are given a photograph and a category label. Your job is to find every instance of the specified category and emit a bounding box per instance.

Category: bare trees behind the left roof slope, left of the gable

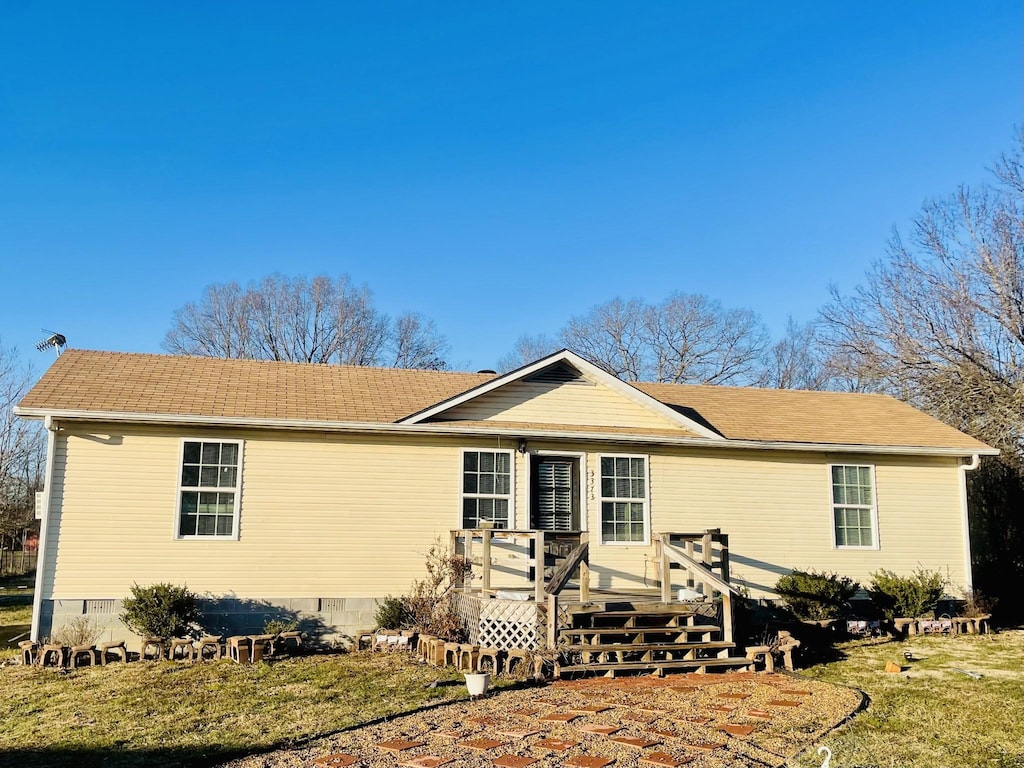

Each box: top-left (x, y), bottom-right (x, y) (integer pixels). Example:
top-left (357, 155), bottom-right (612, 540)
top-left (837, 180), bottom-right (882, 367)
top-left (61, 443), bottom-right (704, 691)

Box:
top-left (164, 274), bottom-right (447, 369)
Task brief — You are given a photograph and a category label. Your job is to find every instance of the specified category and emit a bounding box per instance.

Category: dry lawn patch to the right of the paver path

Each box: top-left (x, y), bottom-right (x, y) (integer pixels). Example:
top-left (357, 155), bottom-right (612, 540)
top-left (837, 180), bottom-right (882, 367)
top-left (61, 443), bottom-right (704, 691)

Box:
top-left (793, 630), bottom-right (1024, 768)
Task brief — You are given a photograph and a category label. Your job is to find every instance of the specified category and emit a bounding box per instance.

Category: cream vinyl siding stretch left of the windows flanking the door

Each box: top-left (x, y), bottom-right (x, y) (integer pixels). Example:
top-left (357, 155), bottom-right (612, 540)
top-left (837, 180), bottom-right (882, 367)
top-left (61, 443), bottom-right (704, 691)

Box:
top-left (47, 429), bottom-right (516, 598)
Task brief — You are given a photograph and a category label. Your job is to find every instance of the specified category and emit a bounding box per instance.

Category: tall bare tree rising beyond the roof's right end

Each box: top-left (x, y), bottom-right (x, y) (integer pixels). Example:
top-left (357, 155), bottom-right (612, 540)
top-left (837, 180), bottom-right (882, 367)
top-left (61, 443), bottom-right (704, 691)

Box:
top-left (821, 134), bottom-right (1024, 460)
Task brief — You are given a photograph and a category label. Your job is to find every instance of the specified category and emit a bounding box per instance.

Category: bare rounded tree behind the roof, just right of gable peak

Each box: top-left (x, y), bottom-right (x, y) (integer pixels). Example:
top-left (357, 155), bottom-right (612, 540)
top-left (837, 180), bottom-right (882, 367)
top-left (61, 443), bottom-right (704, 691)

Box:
top-left (559, 293), bottom-right (768, 384)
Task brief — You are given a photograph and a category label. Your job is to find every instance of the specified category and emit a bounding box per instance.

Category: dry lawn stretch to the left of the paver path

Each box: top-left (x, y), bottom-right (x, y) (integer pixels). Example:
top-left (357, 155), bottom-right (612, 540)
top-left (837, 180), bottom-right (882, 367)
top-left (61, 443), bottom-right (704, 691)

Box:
top-left (0, 653), bottom-right (465, 768)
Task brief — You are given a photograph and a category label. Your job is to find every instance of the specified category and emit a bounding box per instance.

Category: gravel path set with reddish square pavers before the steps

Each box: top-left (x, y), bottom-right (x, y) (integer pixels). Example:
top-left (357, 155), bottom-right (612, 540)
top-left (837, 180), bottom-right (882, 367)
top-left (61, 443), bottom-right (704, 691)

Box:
top-left (224, 673), bottom-right (861, 768)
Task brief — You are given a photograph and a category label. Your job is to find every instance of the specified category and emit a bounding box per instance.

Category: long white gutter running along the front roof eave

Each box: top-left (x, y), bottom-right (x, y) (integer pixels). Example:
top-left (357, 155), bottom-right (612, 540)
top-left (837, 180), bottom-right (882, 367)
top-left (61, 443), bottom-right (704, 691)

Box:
top-left (14, 407), bottom-right (999, 457)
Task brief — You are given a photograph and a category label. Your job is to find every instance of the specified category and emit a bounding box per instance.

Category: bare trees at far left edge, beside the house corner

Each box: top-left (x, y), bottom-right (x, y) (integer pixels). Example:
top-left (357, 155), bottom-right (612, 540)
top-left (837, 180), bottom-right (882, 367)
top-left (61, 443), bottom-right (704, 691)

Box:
top-left (0, 343), bottom-right (45, 561)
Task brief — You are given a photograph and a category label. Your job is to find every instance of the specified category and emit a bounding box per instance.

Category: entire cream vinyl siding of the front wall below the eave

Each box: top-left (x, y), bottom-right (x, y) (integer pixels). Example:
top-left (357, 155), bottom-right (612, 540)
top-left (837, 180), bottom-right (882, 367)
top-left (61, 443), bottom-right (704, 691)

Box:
top-left (42, 425), bottom-right (966, 599)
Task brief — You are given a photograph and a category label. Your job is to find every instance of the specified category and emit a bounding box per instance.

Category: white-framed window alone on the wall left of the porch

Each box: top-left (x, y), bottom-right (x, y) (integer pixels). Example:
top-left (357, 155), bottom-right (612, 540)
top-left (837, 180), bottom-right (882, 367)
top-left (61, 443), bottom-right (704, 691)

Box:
top-left (175, 438), bottom-right (242, 539)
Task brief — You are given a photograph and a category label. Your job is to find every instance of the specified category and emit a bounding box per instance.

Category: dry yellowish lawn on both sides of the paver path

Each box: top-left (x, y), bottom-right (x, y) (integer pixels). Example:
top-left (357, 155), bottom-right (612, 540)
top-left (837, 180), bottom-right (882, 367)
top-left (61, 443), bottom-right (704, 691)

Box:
top-left (0, 595), bottom-right (1024, 768)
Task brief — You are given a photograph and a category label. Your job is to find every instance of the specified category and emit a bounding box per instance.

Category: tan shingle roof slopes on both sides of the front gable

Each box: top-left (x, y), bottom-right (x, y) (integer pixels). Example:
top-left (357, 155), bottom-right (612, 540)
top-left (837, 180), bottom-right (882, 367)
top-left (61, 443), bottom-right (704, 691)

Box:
top-left (19, 349), bottom-right (987, 453)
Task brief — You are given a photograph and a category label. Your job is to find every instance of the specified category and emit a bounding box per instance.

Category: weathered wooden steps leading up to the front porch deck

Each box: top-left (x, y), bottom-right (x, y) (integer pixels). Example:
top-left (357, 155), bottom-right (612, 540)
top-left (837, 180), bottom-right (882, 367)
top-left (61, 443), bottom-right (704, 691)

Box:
top-left (555, 604), bottom-right (751, 677)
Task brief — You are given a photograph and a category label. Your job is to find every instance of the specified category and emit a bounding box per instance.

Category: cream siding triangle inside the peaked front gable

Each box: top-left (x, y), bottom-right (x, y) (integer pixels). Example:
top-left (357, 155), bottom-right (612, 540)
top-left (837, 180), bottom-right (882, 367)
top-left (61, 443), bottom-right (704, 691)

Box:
top-left (443, 381), bottom-right (687, 435)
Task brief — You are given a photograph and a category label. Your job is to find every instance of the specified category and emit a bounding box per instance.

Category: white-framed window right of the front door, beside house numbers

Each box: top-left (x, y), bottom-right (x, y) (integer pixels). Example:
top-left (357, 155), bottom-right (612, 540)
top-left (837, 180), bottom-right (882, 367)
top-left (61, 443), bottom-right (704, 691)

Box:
top-left (600, 455), bottom-right (650, 544)
